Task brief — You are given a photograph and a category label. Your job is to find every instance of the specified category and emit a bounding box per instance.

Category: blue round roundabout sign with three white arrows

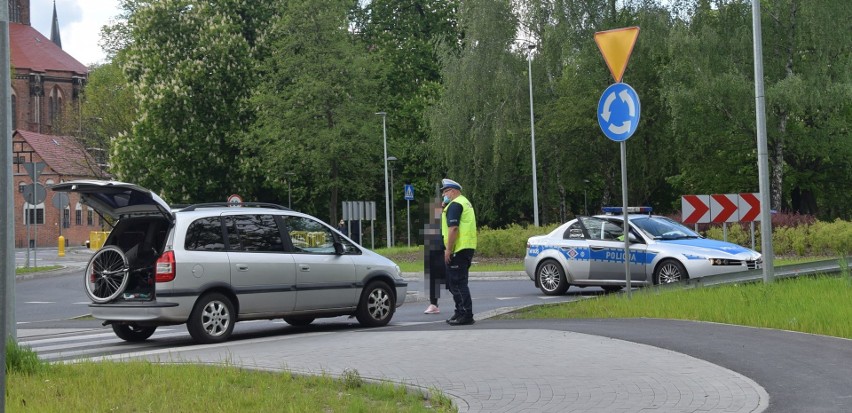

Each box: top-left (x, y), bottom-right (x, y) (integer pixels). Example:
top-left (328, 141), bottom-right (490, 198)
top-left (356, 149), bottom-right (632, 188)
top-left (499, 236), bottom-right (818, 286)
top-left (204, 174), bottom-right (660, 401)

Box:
top-left (598, 83), bottom-right (641, 142)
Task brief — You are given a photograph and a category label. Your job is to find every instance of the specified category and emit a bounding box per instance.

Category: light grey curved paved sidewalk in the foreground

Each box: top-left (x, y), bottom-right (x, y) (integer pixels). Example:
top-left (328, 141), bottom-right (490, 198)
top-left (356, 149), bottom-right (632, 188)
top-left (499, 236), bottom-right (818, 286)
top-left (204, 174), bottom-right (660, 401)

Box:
top-left (103, 321), bottom-right (769, 413)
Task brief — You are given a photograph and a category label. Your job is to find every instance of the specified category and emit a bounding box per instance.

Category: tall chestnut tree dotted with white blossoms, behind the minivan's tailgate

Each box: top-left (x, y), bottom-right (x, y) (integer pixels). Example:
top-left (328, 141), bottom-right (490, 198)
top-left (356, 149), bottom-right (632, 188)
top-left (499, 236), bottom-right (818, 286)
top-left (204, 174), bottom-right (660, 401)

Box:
top-left (111, 0), bottom-right (271, 202)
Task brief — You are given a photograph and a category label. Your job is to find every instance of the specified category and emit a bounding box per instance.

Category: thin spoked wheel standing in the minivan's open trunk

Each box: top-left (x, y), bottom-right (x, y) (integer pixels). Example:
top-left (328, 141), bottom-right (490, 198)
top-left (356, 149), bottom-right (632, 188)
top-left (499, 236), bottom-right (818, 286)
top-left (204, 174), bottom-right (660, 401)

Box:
top-left (84, 245), bottom-right (130, 304)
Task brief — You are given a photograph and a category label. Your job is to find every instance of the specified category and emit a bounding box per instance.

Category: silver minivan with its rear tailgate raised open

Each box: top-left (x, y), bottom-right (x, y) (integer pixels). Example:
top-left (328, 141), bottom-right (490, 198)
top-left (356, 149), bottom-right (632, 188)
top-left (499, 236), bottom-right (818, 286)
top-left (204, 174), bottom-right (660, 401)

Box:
top-left (52, 180), bottom-right (407, 343)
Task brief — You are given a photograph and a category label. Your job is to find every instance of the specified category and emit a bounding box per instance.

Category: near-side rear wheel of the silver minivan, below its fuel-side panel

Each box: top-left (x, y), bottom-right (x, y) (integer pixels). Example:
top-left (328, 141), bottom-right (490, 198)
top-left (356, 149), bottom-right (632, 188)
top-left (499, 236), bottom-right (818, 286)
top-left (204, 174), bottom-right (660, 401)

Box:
top-left (186, 293), bottom-right (236, 344)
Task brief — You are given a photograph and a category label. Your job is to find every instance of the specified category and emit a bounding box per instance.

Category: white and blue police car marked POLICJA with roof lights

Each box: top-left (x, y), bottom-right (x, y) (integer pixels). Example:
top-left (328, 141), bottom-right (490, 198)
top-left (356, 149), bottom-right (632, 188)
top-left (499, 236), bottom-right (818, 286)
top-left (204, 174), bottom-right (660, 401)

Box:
top-left (524, 207), bottom-right (763, 295)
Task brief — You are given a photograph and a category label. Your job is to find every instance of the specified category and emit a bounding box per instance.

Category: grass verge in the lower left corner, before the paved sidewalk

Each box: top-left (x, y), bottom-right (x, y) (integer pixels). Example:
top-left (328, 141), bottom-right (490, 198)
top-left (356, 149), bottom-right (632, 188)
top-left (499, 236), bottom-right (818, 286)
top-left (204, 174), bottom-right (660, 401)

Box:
top-left (6, 343), bottom-right (456, 413)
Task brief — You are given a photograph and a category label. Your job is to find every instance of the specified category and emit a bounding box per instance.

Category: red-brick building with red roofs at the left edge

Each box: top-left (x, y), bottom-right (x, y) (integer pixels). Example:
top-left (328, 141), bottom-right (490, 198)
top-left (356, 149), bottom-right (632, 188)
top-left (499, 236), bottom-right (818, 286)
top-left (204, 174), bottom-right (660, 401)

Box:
top-left (8, 0), bottom-right (106, 247)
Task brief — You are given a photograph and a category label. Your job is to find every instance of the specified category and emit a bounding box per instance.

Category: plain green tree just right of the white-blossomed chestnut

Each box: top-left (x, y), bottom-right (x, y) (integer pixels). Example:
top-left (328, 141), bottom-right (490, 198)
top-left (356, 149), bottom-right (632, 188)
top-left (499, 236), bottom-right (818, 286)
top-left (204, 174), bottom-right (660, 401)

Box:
top-left (244, 0), bottom-right (380, 222)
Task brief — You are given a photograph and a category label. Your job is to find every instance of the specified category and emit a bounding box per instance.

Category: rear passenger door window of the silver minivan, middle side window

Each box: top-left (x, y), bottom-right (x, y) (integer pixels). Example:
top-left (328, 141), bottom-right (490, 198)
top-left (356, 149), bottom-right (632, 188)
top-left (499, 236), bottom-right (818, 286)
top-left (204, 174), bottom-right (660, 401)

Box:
top-left (225, 215), bottom-right (284, 252)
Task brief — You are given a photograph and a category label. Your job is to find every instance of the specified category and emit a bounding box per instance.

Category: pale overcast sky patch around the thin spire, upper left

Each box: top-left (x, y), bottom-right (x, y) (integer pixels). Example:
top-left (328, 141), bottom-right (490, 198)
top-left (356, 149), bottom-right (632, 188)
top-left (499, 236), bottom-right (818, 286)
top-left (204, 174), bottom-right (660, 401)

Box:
top-left (30, 0), bottom-right (119, 66)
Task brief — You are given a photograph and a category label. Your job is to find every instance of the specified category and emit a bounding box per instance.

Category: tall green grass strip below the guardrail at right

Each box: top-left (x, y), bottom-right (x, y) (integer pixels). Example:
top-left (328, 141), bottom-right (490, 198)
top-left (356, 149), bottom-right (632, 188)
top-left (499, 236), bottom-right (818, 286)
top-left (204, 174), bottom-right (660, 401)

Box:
top-left (504, 270), bottom-right (852, 339)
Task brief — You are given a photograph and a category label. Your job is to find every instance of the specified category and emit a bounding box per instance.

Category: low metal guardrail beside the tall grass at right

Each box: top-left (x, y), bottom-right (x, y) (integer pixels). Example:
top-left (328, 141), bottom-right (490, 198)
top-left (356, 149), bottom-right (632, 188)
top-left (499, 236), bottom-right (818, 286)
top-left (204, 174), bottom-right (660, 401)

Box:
top-left (668, 256), bottom-right (852, 288)
